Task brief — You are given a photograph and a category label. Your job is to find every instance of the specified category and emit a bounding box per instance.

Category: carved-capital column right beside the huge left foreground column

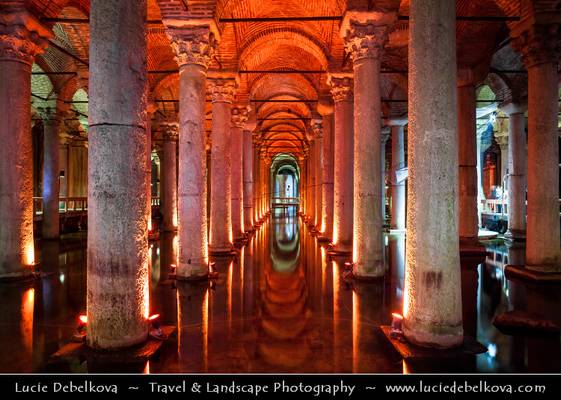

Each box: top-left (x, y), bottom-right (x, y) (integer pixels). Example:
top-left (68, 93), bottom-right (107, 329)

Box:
top-left (164, 25), bottom-right (218, 279)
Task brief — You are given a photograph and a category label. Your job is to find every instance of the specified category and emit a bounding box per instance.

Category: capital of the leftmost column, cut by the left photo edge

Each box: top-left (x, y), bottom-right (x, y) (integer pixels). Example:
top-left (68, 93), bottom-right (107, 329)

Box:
top-left (0, 7), bottom-right (53, 65)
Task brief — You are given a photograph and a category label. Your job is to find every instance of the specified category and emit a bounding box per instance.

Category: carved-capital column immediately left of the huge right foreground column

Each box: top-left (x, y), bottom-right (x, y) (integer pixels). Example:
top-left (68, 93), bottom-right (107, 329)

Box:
top-left (341, 12), bottom-right (396, 278)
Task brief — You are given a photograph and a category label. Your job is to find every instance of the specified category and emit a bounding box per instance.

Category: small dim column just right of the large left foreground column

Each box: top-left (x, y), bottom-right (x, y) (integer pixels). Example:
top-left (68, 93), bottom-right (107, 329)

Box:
top-left (160, 122), bottom-right (179, 232)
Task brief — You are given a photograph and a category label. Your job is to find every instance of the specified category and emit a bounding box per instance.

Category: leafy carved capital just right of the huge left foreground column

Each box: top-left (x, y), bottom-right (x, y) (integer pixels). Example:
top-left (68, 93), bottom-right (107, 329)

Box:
top-left (166, 23), bottom-right (218, 69)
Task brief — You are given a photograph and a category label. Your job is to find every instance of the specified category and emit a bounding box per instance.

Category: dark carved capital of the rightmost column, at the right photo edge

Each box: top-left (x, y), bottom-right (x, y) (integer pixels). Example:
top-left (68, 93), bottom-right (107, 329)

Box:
top-left (512, 24), bottom-right (561, 68)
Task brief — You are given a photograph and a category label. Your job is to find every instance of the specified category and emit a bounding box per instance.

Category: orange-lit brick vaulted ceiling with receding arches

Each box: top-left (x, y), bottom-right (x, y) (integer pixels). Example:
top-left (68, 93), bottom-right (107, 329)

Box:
top-left (19, 0), bottom-right (560, 158)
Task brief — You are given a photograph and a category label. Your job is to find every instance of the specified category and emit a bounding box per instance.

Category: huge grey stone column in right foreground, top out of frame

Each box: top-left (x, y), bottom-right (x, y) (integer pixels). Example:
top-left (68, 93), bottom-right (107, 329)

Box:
top-left (403, 0), bottom-right (463, 348)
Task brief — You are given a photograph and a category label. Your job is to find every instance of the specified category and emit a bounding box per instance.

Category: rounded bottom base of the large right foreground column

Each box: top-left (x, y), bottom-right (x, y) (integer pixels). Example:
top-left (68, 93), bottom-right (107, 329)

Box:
top-left (403, 319), bottom-right (464, 349)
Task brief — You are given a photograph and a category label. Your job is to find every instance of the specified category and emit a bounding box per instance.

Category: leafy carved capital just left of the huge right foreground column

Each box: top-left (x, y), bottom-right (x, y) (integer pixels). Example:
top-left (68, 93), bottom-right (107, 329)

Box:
top-left (340, 11), bottom-right (397, 62)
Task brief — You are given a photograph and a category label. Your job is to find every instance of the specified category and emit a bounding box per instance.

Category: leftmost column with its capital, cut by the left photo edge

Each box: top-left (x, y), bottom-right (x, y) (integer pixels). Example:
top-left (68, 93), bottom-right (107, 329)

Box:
top-left (0, 8), bottom-right (52, 279)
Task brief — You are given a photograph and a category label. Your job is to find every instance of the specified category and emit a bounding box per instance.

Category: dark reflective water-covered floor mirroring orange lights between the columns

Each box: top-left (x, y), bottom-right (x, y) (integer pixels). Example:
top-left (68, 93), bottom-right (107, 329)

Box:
top-left (0, 209), bottom-right (561, 373)
